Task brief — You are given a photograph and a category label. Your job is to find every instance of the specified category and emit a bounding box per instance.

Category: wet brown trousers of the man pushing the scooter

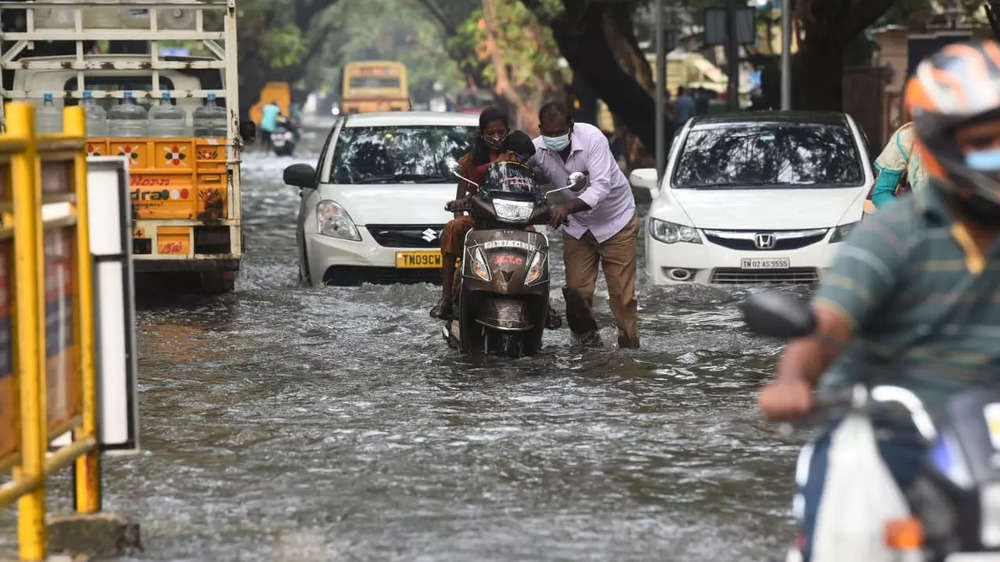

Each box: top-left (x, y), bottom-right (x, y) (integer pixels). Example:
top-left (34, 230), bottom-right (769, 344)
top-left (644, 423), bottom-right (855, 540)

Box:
top-left (563, 216), bottom-right (639, 348)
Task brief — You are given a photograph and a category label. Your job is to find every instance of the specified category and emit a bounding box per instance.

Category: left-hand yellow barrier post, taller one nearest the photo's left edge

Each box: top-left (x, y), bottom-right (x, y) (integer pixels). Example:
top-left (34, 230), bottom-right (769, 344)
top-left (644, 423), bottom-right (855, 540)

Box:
top-left (6, 102), bottom-right (48, 560)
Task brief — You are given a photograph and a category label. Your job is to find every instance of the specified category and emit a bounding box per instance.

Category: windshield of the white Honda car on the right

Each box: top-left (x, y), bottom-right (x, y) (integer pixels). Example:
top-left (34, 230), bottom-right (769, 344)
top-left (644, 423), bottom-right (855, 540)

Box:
top-left (673, 123), bottom-right (864, 189)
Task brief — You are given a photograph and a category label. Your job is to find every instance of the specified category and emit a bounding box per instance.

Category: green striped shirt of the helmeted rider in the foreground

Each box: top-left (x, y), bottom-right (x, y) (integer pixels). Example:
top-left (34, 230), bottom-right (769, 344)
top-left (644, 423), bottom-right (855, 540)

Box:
top-left (815, 186), bottom-right (1000, 410)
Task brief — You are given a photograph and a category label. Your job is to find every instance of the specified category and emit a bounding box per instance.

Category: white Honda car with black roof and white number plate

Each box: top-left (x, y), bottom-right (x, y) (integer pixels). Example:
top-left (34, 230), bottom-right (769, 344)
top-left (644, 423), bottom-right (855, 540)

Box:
top-left (631, 112), bottom-right (874, 285)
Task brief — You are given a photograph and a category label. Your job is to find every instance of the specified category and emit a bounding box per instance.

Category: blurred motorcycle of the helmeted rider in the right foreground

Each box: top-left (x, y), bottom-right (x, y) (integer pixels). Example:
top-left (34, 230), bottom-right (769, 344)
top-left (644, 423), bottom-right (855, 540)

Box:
top-left (743, 292), bottom-right (1000, 562)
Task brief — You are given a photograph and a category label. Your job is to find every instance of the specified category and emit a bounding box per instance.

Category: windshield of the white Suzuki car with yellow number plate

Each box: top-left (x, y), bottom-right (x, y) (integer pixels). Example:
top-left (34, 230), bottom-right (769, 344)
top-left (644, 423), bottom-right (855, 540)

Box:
top-left (329, 126), bottom-right (477, 184)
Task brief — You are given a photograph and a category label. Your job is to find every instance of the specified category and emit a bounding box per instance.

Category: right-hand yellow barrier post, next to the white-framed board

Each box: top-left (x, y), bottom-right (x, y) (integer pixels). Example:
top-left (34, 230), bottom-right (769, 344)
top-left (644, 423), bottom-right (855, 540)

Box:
top-left (63, 107), bottom-right (101, 513)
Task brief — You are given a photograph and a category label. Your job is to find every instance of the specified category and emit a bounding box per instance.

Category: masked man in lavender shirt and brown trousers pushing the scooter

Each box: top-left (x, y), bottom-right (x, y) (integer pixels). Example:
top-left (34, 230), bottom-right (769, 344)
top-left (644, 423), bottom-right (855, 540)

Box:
top-left (534, 102), bottom-right (639, 348)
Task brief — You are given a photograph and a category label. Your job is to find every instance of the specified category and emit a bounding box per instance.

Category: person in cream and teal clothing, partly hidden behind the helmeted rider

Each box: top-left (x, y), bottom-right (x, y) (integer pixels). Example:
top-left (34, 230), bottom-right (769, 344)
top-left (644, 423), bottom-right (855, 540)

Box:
top-left (872, 122), bottom-right (927, 207)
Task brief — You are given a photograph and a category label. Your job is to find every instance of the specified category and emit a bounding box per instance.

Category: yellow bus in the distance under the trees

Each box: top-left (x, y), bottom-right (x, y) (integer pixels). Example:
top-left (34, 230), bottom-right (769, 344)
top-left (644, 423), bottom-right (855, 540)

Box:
top-left (340, 61), bottom-right (410, 114)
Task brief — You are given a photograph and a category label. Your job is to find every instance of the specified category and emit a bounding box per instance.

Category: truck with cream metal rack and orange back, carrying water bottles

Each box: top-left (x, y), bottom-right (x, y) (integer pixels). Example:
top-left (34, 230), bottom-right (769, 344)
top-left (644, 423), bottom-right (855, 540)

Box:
top-left (0, 0), bottom-right (254, 293)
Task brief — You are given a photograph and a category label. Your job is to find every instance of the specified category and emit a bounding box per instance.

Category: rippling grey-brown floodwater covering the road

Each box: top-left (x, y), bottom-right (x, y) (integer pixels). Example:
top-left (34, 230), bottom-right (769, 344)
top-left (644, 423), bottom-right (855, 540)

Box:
top-left (0, 130), bottom-right (798, 561)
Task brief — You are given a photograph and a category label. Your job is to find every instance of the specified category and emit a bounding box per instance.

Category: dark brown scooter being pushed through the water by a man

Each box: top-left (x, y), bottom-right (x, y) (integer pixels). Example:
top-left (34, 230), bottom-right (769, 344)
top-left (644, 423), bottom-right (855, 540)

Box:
top-left (442, 164), bottom-right (586, 358)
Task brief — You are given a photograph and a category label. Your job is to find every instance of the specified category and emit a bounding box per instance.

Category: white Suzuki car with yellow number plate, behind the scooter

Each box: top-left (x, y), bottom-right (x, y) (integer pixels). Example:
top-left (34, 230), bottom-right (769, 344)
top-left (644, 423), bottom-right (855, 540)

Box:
top-left (285, 112), bottom-right (479, 286)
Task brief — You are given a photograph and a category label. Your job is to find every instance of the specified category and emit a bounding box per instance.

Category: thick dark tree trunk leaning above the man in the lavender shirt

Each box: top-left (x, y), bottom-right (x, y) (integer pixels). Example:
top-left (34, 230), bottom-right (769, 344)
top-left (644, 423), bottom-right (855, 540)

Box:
top-left (521, 0), bottom-right (656, 152)
